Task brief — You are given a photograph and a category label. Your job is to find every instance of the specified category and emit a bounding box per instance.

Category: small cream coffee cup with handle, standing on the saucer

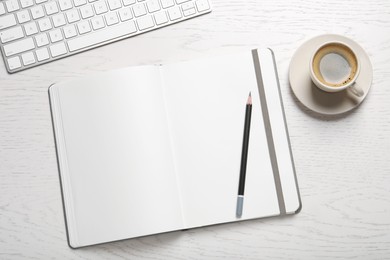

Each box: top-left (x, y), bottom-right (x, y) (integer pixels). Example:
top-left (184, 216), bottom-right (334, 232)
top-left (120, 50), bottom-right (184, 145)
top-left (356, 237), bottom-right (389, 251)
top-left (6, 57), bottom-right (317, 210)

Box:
top-left (310, 41), bottom-right (364, 97)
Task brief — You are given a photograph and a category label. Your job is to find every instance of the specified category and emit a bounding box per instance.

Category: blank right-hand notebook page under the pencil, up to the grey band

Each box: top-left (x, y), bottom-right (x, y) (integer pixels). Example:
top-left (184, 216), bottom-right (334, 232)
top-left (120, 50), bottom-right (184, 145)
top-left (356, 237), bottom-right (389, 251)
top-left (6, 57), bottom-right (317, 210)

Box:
top-left (162, 51), bottom-right (280, 227)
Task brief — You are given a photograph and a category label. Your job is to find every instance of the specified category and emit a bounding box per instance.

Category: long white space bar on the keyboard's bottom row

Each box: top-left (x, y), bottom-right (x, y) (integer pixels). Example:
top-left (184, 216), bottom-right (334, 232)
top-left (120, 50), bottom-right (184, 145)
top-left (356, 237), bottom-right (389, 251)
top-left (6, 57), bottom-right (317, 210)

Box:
top-left (68, 21), bottom-right (137, 51)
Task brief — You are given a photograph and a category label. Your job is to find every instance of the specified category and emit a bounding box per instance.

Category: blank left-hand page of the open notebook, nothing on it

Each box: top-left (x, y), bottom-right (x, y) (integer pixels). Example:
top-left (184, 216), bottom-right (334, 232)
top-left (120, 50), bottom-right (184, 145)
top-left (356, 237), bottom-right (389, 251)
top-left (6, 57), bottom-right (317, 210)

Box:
top-left (51, 66), bottom-right (183, 246)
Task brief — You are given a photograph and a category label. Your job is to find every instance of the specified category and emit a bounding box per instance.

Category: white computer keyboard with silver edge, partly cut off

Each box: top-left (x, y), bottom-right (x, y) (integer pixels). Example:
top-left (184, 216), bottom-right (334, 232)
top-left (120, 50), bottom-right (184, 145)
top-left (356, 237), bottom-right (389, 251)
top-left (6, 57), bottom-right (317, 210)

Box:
top-left (0, 0), bottom-right (211, 73)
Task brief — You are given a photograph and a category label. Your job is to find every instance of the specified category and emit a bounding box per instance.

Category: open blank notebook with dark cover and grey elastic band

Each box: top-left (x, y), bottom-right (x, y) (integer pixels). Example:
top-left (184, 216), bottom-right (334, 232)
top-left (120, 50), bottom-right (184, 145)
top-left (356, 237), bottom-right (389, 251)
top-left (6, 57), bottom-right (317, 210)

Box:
top-left (49, 49), bottom-right (300, 248)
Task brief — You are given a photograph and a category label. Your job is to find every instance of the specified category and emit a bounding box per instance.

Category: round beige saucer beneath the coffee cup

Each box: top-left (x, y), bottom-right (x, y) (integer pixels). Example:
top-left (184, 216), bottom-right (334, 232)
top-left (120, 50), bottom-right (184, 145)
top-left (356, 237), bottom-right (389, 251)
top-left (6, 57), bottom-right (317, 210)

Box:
top-left (289, 34), bottom-right (373, 115)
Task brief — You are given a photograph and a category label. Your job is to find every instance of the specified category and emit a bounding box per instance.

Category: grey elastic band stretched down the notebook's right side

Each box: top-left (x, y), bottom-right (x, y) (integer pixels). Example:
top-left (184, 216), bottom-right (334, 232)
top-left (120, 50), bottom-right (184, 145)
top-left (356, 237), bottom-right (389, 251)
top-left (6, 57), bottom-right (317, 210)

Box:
top-left (252, 50), bottom-right (286, 215)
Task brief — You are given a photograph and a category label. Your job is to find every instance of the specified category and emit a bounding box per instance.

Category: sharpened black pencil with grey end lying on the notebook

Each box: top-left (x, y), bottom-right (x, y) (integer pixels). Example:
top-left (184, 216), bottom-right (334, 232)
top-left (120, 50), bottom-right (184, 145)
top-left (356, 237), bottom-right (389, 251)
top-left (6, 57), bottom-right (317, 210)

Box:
top-left (236, 92), bottom-right (252, 217)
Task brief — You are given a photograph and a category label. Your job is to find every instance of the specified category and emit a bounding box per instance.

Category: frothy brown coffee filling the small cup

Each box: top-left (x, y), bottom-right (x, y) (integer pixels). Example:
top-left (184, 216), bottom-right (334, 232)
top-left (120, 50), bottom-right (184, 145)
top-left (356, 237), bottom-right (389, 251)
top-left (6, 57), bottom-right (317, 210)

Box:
top-left (311, 42), bottom-right (358, 88)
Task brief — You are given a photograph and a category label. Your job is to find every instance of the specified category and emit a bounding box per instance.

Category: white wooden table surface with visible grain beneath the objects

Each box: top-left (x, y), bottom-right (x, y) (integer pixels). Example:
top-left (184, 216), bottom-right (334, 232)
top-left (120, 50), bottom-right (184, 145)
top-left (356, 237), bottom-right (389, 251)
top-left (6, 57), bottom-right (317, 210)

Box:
top-left (0, 0), bottom-right (390, 259)
